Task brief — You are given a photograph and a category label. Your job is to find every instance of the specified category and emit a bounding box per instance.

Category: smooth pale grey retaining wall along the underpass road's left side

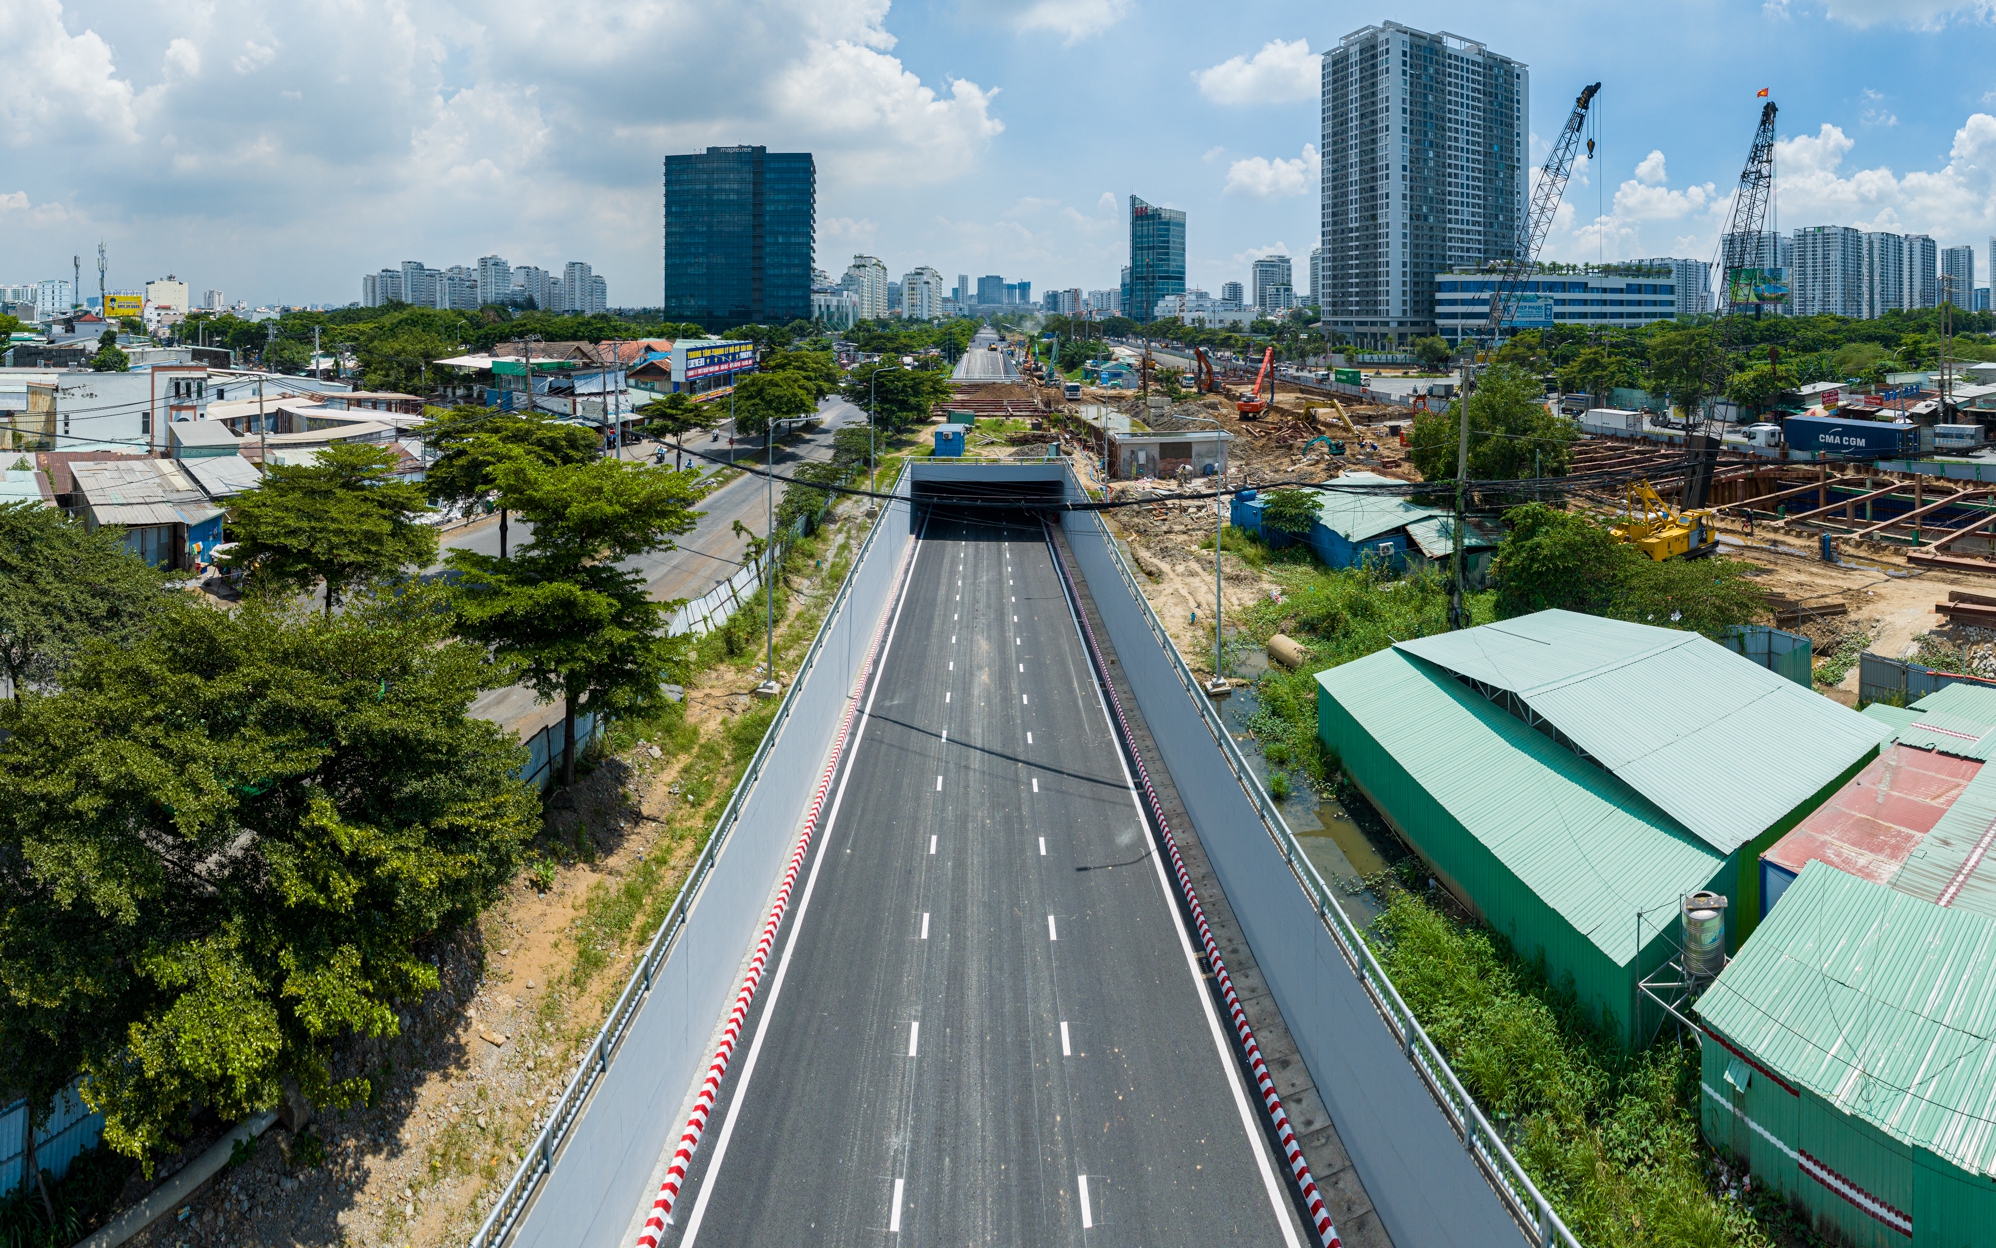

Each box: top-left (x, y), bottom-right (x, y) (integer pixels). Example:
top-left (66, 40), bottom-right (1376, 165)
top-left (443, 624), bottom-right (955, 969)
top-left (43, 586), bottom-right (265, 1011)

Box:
top-left (497, 487), bottom-right (908, 1248)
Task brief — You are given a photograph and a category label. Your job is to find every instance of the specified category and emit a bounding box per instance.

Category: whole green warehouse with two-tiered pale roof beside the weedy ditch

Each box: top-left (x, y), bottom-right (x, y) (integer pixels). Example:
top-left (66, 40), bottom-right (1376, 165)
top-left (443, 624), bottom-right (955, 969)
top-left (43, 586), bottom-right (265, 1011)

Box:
top-left (1317, 611), bottom-right (1890, 1044)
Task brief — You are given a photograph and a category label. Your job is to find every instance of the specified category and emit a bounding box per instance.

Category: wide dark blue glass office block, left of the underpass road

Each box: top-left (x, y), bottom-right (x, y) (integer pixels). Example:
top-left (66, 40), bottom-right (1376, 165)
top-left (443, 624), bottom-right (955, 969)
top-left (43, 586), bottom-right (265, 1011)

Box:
top-left (665, 146), bottom-right (814, 329)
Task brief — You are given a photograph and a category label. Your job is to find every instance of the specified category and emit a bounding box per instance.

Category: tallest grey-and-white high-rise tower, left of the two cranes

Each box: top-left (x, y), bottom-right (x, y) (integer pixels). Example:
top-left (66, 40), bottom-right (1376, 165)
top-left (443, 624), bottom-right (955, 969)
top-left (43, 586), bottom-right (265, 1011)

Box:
top-left (1317, 22), bottom-right (1531, 347)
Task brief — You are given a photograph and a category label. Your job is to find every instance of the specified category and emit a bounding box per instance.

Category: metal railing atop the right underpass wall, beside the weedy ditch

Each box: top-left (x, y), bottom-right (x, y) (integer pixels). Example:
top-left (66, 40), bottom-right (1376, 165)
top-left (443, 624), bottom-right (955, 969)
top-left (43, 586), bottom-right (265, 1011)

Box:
top-left (1096, 489), bottom-right (1581, 1248)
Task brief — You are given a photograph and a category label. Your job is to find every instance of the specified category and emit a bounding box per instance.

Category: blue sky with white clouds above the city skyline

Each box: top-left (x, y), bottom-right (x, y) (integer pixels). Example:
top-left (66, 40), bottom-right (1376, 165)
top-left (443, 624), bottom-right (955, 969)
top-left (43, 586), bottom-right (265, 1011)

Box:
top-left (0, 0), bottom-right (1996, 308)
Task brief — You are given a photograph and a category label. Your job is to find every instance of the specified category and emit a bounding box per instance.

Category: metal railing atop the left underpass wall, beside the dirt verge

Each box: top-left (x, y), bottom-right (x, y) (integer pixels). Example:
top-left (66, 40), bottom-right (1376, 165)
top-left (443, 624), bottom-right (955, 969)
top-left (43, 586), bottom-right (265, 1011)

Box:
top-left (471, 467), bottom-right (906, 1248)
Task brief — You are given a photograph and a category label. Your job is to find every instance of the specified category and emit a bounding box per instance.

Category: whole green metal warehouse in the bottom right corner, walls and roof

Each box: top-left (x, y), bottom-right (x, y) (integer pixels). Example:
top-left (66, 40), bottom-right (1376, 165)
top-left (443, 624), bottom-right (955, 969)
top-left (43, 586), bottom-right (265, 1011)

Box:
top-left (1699, 863), bottom-right (1996, 1248)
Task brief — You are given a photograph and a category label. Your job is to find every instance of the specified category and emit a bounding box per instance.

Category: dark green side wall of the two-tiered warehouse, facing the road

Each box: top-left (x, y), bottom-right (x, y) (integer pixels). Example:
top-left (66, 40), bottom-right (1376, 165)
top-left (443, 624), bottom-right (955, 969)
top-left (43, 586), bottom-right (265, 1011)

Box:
top-left (1317, 687), bottom-right (1700, 1046)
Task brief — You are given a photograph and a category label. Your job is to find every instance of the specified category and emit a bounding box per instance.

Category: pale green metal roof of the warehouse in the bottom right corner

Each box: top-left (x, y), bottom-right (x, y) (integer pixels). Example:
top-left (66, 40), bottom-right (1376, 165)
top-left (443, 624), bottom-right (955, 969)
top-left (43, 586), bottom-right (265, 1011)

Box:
top-left (1699, 863), bottom-right (1996, 1174)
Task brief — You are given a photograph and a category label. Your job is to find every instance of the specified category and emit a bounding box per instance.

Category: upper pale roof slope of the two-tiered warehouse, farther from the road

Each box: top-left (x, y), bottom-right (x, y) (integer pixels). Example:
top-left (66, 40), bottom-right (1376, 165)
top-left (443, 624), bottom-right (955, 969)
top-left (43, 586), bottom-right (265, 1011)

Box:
top-left (1399, 611), bottom-right (1890, 853)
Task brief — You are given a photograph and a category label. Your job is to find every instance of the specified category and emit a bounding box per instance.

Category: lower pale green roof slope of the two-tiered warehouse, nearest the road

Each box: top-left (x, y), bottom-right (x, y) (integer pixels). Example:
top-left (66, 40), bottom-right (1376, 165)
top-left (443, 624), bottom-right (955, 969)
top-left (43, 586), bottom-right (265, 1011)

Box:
top-left (1317, 651), bottom-right (1724, 962)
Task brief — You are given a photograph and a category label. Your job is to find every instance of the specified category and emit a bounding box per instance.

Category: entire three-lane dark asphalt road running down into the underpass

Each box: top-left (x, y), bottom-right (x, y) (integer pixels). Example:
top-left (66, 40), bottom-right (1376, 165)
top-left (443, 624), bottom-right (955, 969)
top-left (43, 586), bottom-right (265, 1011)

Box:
top-left (647, 507), bottom-right (1305, 1248)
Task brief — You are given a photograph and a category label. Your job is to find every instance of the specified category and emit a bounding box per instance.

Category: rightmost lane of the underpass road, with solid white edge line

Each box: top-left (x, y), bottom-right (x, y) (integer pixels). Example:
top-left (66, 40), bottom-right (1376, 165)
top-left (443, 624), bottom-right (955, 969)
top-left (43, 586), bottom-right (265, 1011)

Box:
top-left (1010, 527), bottom-right (1305, 1246)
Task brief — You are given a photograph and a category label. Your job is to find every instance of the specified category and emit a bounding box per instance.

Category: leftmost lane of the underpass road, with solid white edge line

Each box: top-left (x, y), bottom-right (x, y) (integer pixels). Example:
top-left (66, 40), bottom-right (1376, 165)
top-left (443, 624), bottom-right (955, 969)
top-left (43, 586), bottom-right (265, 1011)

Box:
top-left (673, 511), bottom-right (954, 1244)
